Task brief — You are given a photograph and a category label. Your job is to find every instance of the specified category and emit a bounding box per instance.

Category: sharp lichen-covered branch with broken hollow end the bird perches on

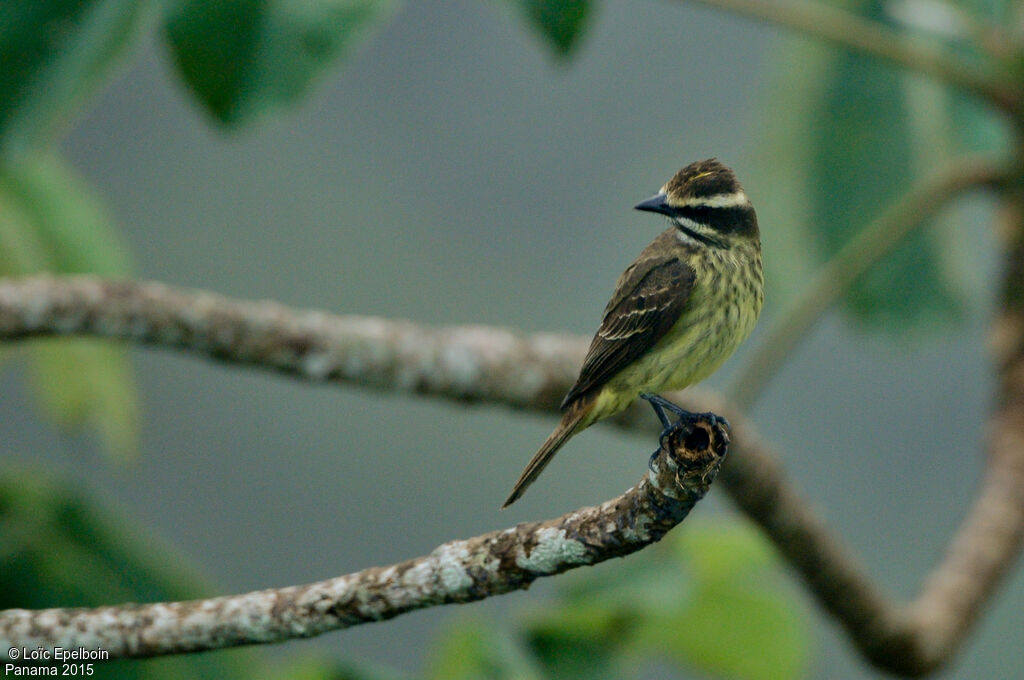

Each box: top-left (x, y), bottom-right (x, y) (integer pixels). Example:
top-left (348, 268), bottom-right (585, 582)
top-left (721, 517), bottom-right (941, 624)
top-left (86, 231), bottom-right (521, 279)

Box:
top-left (0, 418), bottom-right (728, 657)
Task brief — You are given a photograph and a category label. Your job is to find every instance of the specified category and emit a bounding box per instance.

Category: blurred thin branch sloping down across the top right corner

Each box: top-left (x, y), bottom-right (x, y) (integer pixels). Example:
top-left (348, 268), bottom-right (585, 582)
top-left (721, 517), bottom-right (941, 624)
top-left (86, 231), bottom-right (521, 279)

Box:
top-left (675, 0), bottom-right (1024, 118)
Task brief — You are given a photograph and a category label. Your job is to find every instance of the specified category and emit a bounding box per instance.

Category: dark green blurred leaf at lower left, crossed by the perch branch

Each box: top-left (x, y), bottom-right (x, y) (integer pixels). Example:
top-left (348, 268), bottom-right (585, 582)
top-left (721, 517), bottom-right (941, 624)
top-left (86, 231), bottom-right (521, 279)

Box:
top-left (0, 468), bottom-right (260, 680)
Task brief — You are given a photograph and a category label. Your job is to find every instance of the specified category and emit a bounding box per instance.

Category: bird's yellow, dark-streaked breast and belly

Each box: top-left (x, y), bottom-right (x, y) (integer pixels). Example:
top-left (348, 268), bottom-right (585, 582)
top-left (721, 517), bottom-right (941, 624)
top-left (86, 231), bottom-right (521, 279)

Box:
top-left (594, 245), bottom-right (764, 420)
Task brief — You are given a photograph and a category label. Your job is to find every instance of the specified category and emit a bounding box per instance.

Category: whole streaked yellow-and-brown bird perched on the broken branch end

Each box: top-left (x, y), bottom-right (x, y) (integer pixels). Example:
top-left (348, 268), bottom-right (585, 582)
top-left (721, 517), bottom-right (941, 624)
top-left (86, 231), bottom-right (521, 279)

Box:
top-left (502, 159), bottom-right (764, 508)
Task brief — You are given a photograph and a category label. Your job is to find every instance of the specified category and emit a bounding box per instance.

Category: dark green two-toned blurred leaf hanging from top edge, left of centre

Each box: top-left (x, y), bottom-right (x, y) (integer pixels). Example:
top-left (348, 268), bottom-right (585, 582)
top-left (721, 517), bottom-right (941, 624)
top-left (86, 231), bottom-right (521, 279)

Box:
top-left (166, 0), bottom-right (396, 125)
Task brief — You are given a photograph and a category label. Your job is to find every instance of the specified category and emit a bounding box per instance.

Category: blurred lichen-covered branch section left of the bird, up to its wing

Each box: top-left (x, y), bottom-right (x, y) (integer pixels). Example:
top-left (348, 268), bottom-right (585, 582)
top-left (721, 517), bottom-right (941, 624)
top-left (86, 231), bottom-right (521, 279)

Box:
top-left (0, 275), bottom-right (586, 411)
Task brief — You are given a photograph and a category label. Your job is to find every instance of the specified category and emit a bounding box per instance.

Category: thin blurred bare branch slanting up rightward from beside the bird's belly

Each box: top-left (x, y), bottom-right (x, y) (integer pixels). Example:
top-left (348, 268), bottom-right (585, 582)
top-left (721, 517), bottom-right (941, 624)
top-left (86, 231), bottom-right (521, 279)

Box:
top-left (726, 157), bottom-right (1011, 410)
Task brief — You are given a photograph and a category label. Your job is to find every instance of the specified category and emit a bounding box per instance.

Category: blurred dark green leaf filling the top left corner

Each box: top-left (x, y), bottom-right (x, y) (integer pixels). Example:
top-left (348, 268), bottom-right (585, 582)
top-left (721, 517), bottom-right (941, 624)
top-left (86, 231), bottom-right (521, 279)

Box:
top-left (0, 0), bottom-right (144, 161)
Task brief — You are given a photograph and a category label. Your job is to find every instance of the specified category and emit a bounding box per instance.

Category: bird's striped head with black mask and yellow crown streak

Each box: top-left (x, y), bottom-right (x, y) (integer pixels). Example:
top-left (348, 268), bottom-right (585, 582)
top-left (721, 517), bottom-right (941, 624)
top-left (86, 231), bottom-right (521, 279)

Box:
top-left (636, 159), bottom-right (759, 248)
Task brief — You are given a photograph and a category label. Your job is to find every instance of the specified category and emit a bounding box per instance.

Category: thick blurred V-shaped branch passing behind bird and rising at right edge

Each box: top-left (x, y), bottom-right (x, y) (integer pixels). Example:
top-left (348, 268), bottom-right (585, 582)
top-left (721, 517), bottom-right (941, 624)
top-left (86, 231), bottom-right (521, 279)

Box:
top-left (0, 274), bottom-right (1024, 674)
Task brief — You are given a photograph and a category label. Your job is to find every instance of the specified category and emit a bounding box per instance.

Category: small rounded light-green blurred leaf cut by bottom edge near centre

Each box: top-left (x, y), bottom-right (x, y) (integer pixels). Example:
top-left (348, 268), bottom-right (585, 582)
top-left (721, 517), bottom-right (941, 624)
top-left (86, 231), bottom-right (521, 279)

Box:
top-left (425, 620), bottom-right (542, 680)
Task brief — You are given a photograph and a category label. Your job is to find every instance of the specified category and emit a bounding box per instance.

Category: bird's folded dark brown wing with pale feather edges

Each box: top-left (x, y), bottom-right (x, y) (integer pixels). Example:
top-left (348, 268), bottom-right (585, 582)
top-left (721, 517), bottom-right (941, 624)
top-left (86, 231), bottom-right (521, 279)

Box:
top-left (562, 255), bottom-right (694, 409)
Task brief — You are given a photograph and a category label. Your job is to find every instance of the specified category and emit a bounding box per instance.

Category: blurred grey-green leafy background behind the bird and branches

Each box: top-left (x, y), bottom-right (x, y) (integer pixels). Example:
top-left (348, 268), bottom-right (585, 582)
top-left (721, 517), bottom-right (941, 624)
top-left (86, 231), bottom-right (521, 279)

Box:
top-left (0, 0), bottom-right (1024, 678)
